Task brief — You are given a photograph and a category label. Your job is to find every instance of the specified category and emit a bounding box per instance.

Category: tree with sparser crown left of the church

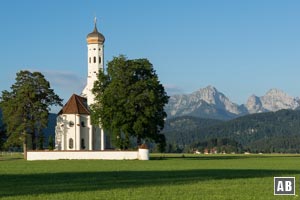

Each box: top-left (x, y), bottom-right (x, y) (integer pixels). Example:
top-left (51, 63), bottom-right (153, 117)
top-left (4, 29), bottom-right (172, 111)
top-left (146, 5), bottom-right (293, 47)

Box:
top-left (0, 71), bottom-right (62, 158)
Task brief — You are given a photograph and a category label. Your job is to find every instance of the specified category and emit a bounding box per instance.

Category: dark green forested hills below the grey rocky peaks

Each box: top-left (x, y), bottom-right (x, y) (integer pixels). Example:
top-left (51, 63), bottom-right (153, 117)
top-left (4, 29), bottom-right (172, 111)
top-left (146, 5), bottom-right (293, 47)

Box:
top-left (163, 110), bottom-right (300, 153)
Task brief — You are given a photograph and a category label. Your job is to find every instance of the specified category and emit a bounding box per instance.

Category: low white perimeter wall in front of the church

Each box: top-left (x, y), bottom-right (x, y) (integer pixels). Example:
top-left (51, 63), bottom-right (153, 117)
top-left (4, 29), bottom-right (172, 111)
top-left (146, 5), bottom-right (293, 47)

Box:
top-left (27, 149), bottom-right (149, 160)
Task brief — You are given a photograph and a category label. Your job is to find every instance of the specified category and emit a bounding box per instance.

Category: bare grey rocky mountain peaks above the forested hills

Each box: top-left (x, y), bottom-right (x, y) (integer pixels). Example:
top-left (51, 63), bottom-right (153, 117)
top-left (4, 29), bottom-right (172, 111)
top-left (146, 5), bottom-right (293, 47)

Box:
top-left (165, 85), bottom-right (300, 120)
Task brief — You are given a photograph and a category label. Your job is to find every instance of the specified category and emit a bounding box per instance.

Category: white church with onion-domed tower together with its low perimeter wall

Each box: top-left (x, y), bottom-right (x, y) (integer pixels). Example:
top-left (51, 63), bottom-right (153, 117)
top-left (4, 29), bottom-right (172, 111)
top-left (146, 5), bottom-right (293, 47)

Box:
top-left (27, 19), bottom-right (149, 160)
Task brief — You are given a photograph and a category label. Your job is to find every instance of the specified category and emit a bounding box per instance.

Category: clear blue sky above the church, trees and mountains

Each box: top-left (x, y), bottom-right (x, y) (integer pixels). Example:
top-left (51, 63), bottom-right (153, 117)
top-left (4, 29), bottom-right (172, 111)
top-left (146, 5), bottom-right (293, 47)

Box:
top-left (0, 0), bottom-right (300, 111)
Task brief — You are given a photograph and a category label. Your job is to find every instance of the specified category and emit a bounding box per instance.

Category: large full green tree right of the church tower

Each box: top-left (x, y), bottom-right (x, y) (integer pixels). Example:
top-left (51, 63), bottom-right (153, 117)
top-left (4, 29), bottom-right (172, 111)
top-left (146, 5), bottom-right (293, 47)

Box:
top-left (91, 56), bottom-right (169, 149)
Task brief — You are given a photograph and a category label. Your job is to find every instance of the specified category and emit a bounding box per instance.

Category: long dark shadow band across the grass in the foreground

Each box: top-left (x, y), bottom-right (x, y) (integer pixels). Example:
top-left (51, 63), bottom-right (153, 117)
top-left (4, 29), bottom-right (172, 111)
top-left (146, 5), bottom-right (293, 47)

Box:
top-left (0, 169), bottom-right (300, 197)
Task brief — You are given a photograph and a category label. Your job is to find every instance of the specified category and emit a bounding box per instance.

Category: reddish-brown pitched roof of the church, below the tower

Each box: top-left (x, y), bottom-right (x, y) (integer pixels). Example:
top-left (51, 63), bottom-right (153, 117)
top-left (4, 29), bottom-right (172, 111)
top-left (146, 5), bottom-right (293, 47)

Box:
top-left (58, 94), bottom-right (90, 115)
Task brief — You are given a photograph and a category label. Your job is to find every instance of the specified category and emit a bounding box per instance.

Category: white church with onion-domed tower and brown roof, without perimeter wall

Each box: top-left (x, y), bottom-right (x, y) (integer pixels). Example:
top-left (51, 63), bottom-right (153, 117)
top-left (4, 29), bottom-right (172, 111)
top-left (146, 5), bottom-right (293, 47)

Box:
top-left (55, 20), bottom-right (105, 150)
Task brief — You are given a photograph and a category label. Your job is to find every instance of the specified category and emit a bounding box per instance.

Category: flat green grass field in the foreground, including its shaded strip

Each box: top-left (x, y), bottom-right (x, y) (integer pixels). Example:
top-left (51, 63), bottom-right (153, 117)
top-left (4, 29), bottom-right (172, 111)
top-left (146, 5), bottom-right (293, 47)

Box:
top-left (0, 154), bottom-right (300, 200)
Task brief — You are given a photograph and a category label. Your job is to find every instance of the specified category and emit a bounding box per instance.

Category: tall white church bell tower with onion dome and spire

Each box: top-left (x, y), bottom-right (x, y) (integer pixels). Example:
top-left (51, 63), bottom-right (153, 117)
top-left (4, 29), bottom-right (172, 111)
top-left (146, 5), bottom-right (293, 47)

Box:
top-left (82, 18), bottom-right (105, 105)
